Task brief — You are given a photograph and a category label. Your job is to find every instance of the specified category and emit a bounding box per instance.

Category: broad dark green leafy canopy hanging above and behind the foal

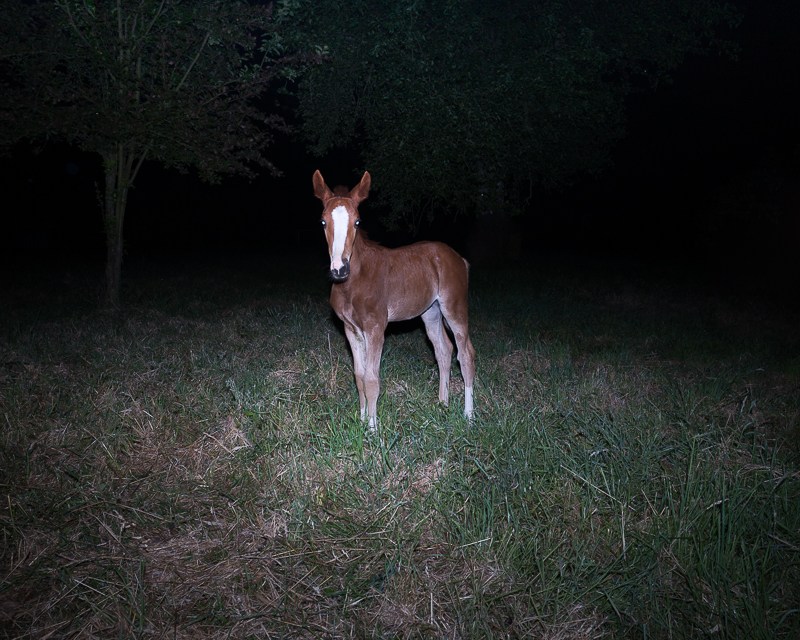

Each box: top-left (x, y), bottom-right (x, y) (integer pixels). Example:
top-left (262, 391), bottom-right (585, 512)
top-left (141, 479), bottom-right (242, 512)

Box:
top-left (300, 0), bottom-right (735, 230)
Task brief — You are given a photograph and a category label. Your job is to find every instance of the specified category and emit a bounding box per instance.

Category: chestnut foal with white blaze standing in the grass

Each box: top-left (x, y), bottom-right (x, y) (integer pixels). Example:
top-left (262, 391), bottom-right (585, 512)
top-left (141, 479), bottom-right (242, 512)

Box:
top-left (313, 171), bottom-right (475, 429)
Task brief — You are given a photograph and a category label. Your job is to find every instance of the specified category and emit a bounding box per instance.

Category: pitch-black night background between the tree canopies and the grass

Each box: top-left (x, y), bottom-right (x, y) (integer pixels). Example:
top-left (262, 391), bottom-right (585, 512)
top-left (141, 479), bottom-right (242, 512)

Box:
top-left (2, 0), bottom-right (800, 296)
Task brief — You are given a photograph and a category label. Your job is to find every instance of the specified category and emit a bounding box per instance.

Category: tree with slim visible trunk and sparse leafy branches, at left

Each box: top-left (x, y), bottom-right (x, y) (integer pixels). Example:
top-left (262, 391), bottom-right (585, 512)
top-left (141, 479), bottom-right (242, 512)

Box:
top-left (0, 0), bottom-right (305, 307)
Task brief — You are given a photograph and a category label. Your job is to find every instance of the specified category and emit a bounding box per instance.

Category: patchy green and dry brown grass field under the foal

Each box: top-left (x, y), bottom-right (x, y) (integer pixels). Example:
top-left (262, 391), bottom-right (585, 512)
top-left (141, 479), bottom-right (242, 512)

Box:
top-left (0, 256), bottom-right (800, 640)
